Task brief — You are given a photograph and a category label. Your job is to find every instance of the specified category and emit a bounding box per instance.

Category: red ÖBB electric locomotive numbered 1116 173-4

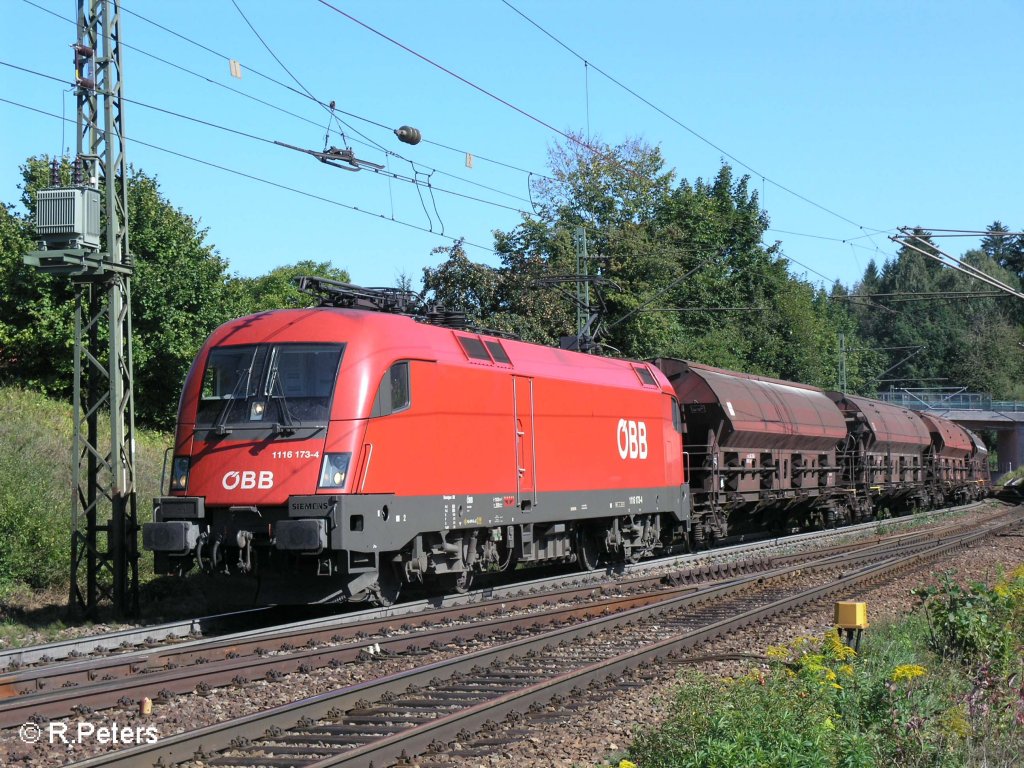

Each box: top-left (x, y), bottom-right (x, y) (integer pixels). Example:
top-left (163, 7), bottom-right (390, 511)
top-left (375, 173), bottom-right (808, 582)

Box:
top-left (143, 281), bottom-right (689, 603)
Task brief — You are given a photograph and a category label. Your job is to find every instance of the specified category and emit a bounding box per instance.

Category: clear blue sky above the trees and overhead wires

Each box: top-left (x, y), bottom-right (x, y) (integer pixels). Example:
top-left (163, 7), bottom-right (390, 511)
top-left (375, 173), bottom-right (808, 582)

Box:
top-left (0, 0), bottom-right (1024, 286)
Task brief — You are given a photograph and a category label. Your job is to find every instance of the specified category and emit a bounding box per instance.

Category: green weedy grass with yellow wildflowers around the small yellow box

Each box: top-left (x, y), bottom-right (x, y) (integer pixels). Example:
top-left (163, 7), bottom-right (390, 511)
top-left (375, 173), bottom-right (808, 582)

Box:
top-left (629, 566), bottom-right (1024, 768)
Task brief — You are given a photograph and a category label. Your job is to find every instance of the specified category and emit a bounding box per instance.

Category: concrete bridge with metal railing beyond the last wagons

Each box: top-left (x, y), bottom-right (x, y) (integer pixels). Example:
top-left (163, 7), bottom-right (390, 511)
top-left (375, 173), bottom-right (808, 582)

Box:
top-left (878, 387), bottom-right (1024, 476)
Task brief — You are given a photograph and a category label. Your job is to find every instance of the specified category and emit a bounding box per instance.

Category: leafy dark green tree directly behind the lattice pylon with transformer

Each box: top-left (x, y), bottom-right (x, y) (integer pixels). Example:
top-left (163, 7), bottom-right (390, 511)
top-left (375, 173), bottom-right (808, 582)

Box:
top-left (0, 157), bottom-right (230, 426)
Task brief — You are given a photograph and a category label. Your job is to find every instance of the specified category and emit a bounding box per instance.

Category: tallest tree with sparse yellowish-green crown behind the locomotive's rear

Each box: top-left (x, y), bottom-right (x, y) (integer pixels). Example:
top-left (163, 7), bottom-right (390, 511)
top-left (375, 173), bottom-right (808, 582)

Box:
top-left (495, 134), bottom-right (679, 356)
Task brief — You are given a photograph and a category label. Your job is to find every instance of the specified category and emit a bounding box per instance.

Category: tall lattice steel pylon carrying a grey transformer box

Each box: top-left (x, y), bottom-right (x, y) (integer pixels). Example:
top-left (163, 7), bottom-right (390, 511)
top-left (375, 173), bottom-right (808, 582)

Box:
top-left (26, 0), bottom-right (138, 615)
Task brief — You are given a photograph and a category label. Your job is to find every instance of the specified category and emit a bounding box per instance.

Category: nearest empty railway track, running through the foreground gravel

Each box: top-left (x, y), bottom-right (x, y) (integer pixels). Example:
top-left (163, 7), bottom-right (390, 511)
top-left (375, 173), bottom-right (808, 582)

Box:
top-left (41, 511), bottom-right (1021, 768)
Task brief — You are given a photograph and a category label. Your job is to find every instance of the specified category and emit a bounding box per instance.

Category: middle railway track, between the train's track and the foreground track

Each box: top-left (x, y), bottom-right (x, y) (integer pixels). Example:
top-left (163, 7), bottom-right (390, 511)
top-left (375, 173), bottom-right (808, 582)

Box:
top-left (0, 505), bottom-right (1003, 727)
